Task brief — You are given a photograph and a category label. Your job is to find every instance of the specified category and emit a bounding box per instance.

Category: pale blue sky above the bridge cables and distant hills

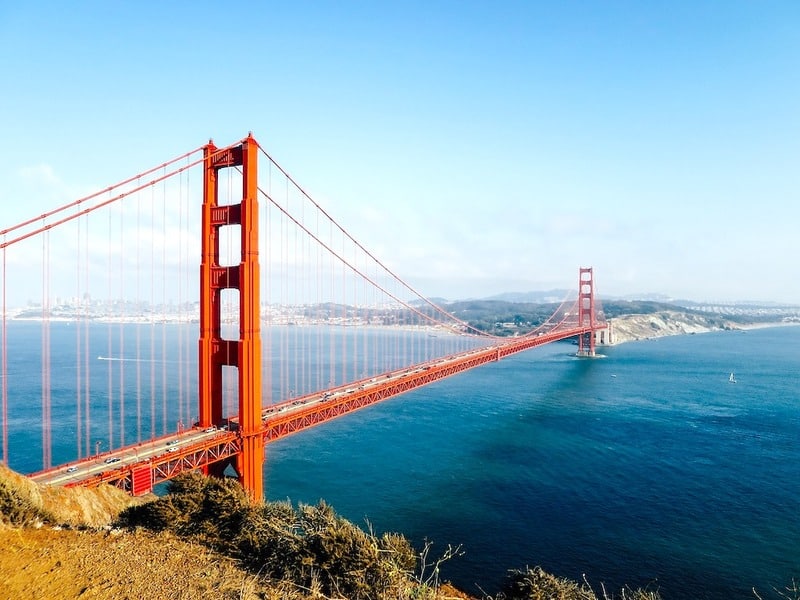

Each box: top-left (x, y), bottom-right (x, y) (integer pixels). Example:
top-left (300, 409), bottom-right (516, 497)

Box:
top-left (0, 0), bottom-right (800, 304)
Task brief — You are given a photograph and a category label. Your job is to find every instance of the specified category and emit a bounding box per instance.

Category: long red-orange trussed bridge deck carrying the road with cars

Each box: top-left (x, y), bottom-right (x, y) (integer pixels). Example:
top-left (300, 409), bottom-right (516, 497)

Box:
top-left (30, 323), bottom-right (606, 495)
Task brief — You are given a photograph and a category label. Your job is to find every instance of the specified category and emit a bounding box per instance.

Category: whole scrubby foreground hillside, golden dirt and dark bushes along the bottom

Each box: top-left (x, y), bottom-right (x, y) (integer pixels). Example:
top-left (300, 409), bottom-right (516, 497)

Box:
top-left (0, 458), bottom-right (800, 600)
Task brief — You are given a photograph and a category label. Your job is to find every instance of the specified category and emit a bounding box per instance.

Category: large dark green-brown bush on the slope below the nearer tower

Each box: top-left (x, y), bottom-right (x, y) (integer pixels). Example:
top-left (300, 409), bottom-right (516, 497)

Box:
top-left (118, 473), bottom-right (417, 600)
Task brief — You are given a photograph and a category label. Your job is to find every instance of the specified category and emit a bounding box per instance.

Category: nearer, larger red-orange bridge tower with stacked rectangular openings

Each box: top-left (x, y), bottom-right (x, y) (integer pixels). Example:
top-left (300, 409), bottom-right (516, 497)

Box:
top-left (199, 135), bottom-right (264, 500)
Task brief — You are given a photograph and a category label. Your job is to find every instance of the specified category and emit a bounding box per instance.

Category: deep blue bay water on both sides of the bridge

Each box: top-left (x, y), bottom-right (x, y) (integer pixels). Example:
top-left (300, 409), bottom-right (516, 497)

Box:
top-left (3, 324), bottom-right (800, 600)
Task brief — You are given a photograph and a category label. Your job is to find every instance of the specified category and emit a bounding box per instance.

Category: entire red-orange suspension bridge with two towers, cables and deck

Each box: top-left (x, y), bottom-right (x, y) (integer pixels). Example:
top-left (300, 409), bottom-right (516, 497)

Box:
top-left (0, 135), bottom-right (607, 499)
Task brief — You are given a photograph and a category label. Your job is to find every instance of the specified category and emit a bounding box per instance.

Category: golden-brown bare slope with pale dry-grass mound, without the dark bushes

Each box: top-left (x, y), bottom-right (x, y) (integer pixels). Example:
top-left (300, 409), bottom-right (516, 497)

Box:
top-left (0, 465), bottom-right (468, 600)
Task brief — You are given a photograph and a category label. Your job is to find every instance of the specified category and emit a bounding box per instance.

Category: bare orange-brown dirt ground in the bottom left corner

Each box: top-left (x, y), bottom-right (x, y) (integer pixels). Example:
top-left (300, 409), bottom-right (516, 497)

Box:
top-left (0, 527), bottom-right (278, 600)
